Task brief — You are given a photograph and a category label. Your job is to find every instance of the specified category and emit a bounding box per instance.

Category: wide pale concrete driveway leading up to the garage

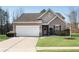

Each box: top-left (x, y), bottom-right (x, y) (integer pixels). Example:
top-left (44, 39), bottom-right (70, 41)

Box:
top-left (0, 37), bottom-right (38, 52)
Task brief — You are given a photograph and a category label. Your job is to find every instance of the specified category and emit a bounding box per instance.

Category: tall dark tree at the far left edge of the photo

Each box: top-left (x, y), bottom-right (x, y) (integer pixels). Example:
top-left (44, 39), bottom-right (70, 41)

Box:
top-left (0, 8), bottom-right (9, 34)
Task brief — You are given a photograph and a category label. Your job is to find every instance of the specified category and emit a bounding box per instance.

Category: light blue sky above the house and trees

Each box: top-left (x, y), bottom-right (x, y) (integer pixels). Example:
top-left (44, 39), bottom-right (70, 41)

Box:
top-left (1, 6), bottom-right (79, 22)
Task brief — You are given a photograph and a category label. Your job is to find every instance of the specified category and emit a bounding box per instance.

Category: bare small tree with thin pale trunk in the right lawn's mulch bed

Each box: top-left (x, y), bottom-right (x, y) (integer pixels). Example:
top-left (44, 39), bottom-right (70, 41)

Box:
top-left (63, 7), bottom-right (78, 39)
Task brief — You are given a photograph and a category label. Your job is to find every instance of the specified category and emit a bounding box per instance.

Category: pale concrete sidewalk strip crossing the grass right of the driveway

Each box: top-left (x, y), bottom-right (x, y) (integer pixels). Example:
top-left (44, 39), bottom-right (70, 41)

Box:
top-left (36, 47), bottom-right (79, 50)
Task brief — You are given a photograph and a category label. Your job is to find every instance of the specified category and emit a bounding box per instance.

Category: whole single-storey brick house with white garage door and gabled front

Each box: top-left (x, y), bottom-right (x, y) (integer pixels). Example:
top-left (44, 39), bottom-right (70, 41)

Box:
top-left (13, 9), bottom-right (66, 36)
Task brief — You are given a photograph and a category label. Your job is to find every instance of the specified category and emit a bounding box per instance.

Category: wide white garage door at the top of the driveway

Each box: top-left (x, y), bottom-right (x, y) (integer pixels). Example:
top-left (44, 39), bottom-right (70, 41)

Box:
top-left (16, 25), bottom-right (40, 36)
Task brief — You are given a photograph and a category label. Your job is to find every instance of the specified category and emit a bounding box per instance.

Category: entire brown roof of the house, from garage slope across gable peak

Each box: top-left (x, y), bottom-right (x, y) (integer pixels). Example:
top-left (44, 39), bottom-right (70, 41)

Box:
top-left (14, 9), bottom-right (64, 22)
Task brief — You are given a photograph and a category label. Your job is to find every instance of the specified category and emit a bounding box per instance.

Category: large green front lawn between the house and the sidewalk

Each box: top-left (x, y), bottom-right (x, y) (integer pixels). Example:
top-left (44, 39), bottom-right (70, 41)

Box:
top-left (37, 33), bottom-right (79, 47)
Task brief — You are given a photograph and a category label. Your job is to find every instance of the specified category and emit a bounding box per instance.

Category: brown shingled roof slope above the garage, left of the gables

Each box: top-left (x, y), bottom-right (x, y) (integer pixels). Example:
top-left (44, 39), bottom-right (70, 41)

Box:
top-left (14, 13), bottom-right (41, 22)
